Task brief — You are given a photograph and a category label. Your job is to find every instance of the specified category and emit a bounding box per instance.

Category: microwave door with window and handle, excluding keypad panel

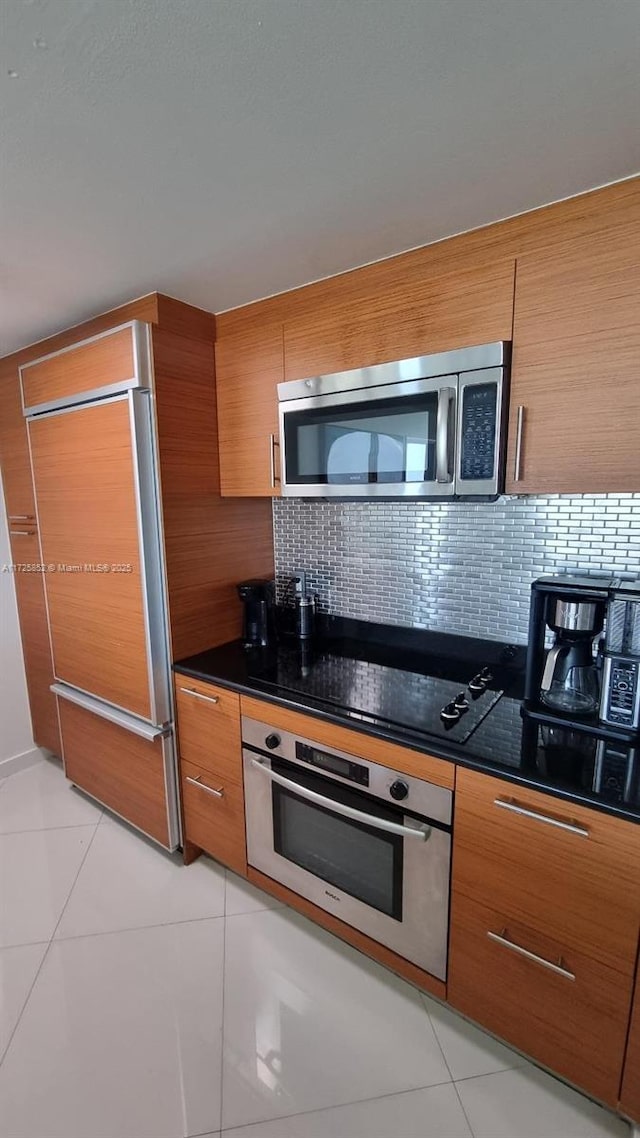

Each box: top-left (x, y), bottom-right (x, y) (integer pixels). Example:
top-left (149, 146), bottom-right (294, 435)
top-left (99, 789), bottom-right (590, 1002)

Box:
top-left (280, 376), bottom-right (458, 497)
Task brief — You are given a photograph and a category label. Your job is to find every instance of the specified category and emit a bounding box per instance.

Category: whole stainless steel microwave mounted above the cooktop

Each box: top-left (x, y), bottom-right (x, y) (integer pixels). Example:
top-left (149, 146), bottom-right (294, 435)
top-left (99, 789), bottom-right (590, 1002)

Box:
top-left (278, 341), bottom-right (510, 498)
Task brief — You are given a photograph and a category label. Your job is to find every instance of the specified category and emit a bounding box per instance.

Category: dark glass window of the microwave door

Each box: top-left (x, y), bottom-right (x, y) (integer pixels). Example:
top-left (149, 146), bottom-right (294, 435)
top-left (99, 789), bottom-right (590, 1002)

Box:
top-left (285, 393), bottom-right (437, 486)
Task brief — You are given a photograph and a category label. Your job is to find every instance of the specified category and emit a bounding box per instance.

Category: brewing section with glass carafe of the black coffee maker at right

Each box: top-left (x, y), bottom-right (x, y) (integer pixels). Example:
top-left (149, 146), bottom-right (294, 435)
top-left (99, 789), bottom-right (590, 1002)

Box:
top-left (525, 576), bottom-right (607, 723)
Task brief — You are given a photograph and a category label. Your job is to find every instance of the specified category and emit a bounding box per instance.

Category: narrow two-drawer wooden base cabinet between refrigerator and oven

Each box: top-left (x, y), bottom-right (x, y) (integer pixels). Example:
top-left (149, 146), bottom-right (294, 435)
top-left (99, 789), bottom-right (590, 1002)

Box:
top-left (175, 674), bottom-right (247, 876)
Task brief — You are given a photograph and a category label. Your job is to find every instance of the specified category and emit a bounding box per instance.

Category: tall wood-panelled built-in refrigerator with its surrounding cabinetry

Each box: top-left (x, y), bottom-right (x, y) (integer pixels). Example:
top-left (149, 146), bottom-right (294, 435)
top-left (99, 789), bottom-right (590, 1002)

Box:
top-left (0, 294), bottom-right (273, 848)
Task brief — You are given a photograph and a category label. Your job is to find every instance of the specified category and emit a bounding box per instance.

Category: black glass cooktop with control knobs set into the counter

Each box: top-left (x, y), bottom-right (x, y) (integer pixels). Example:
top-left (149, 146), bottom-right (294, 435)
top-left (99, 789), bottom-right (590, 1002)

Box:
top-left (248, 650), bottom-right (502, 743)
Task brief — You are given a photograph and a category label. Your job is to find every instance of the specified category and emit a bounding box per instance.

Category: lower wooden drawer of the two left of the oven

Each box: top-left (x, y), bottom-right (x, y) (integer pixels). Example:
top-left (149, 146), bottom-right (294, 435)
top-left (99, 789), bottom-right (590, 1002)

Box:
top-left (181, 762), bottom-right (247, 876)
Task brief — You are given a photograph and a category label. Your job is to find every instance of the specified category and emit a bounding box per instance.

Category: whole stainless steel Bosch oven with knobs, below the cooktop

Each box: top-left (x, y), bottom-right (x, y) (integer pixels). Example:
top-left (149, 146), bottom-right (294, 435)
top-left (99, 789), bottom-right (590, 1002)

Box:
top-left (243, 717), bottom-right (453, 980)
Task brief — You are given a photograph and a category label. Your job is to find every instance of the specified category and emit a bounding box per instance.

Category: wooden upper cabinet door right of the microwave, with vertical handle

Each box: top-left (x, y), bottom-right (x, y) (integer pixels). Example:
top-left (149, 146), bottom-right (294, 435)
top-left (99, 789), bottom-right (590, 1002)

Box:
top-left (507, 231), bottom-right (640, 494)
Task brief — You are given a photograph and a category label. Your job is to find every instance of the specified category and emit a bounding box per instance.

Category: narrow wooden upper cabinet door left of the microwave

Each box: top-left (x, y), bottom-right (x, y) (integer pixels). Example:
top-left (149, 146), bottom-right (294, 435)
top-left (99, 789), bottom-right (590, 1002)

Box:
top-left (215, 324), bottom-right (284, 497)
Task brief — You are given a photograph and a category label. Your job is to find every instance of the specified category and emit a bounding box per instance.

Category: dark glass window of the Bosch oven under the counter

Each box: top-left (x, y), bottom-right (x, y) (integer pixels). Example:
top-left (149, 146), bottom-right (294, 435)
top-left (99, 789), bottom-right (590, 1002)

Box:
top-left (273, 768), bottom-right (402, 921)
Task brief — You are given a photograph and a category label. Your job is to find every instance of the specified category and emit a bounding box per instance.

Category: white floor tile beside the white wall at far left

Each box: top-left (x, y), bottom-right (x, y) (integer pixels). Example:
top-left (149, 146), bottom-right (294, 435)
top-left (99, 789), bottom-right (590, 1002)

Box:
top-left (0, 759), bottom-right (102, 834)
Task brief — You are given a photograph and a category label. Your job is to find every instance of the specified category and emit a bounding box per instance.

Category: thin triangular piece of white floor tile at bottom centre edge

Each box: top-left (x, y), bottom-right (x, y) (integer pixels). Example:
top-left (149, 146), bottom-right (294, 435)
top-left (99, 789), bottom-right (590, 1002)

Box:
top-left (223, 1083), bottom-right (471, 1138)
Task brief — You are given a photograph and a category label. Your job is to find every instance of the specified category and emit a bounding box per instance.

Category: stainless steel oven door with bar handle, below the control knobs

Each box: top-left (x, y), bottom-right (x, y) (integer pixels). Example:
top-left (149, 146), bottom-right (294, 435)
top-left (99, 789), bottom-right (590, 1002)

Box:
top-left (243, 750), bottom-right (451, 980)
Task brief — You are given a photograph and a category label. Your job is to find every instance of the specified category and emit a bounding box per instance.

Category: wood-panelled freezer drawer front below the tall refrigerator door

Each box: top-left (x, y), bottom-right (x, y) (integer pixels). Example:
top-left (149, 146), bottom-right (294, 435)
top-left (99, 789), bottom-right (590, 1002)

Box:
top-left (58, 699), bottom-right (170, 848)
